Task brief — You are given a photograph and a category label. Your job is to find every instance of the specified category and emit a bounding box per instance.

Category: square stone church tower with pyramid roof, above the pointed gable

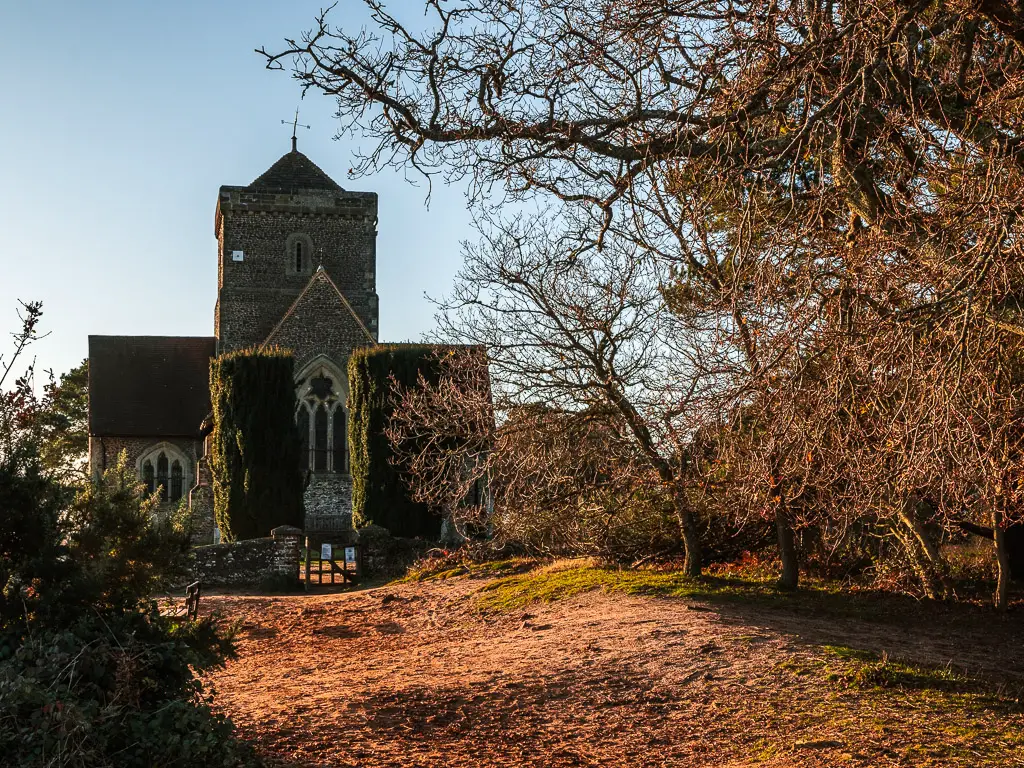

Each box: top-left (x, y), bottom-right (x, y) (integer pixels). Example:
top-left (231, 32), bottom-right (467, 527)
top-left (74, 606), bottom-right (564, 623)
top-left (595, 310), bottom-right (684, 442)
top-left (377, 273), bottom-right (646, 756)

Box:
top-left (214, 141), bottom-right (378, 360)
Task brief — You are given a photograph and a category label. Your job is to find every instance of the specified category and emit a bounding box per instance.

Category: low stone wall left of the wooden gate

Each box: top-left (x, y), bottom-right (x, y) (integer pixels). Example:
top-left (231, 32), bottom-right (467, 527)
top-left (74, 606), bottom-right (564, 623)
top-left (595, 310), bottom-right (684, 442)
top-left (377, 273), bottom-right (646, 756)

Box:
top-left (193, 525), bottom-right (302, 589)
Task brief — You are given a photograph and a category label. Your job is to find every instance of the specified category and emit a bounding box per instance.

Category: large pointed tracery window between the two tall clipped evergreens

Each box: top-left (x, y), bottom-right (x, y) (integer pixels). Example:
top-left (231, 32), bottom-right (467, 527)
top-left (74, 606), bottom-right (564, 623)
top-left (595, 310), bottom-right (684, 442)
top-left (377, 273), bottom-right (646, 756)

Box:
top-left (295, 366), bottom-right (348, 473)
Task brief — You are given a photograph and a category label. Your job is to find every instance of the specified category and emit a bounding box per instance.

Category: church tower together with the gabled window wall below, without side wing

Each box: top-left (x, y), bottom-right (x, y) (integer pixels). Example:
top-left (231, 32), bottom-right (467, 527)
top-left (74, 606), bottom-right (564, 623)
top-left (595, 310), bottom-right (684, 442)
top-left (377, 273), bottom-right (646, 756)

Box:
top-left (214, 137), bottom-right (378, 531)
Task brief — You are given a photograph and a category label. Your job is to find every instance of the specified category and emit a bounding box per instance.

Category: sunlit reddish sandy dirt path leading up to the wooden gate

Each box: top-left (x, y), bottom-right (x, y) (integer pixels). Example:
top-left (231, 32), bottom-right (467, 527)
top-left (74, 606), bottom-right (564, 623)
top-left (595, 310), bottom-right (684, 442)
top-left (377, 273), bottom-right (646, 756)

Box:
top-left (204, 579), bottom-right (1024, 768)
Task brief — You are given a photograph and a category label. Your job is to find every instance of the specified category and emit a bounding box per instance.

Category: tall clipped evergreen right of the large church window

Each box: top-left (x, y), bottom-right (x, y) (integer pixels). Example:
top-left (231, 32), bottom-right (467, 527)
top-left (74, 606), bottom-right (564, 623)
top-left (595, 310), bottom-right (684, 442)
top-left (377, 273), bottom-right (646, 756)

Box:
top-left (348, 344), bottom-right (441, 539)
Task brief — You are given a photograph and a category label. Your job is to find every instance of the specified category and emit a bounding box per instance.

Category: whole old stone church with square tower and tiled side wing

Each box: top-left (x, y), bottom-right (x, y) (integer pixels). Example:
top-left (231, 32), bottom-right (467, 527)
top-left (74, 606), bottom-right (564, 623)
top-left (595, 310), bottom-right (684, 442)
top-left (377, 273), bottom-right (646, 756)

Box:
top-left (89, 136), bottom-right (378, 543)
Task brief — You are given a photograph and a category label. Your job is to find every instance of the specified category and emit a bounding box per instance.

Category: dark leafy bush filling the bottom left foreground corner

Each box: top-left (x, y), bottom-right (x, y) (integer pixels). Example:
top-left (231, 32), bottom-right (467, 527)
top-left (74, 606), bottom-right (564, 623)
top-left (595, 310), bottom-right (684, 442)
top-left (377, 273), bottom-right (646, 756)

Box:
top-left (0, 453), bottom-right (257, 768)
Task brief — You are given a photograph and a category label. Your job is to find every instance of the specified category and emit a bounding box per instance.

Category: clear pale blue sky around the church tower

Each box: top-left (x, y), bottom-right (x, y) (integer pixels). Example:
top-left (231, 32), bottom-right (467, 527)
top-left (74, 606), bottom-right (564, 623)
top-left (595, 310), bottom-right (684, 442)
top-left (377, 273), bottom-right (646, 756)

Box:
top-left (0, 0), bottom-right (471, 382)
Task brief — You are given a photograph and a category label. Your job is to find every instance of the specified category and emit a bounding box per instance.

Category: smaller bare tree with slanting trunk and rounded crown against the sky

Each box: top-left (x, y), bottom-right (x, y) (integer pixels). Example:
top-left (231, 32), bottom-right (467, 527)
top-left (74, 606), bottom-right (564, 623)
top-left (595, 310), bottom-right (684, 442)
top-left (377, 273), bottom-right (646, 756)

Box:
top-left (419, 218), bottom-right (730, 573)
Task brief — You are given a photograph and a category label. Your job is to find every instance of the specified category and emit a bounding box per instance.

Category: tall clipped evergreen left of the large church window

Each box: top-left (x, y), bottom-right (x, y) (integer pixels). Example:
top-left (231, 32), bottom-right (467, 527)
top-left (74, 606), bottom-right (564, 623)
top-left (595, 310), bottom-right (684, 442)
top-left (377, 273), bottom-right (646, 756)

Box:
top-left (210, 348), bottom-right (305, 541)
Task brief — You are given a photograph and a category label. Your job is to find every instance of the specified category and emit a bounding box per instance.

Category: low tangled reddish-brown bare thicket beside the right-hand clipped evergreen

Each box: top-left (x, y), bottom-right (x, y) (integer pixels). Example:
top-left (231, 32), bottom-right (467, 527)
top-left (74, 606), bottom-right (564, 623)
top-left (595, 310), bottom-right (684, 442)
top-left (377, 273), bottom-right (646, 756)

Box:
top-left (387, 347), bottom-right (678, 558)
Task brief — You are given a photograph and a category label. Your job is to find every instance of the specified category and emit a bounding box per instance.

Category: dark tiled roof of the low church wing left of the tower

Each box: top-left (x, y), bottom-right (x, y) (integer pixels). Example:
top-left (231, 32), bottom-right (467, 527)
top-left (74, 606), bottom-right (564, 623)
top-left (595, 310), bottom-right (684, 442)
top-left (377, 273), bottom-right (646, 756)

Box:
top-left (89, 336), bottom-right (217, 437)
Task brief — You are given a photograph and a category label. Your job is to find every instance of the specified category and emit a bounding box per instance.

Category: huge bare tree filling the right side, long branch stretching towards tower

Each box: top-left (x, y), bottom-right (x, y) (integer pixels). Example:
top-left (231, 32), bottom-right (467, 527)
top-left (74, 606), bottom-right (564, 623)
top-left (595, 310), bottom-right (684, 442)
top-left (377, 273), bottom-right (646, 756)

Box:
top-left (263, 0), bottom-right (1024, 594)
